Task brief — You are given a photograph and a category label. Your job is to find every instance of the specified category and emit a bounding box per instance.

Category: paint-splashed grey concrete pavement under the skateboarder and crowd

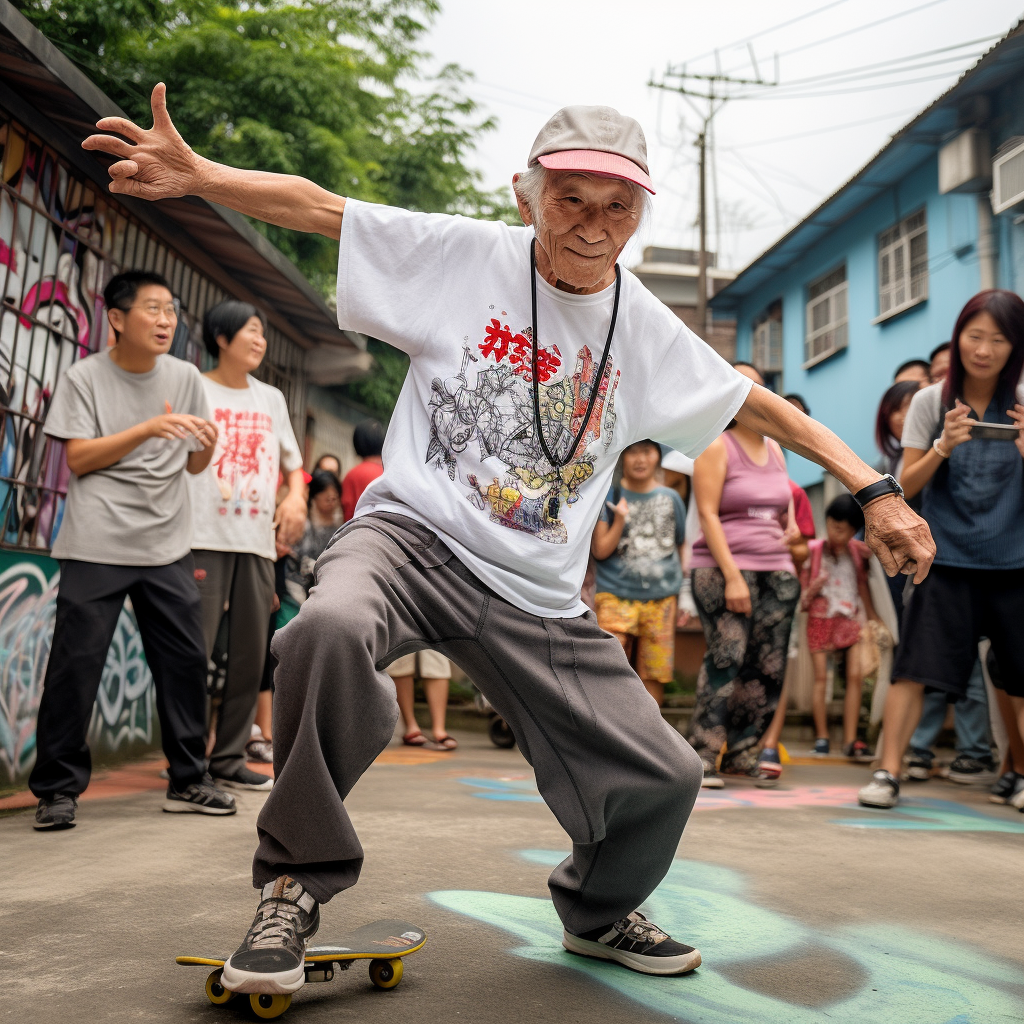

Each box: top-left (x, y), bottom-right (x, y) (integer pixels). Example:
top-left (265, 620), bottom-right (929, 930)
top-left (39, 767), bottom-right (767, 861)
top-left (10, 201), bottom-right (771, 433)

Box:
top-left (0, 732), bottom-right (1024, 1024)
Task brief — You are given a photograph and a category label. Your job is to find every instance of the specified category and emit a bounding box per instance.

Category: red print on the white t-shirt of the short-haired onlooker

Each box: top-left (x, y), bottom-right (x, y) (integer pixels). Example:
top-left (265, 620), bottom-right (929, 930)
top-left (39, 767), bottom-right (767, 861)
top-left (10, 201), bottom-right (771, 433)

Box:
top-left (210, 408), bottom-right (278, 518)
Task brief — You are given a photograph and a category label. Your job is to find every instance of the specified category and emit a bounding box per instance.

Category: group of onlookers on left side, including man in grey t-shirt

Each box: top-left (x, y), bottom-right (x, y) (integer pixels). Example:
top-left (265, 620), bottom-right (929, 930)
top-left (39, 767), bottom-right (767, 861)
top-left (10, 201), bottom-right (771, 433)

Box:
top-left (29, 270), bottom-right (457, 830)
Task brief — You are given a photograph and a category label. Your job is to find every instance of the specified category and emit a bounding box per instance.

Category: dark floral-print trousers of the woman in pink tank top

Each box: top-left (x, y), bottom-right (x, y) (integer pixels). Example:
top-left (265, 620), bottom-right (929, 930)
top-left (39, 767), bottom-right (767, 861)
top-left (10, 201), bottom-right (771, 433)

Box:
top-left (687, 568), bottom-right (800, 772)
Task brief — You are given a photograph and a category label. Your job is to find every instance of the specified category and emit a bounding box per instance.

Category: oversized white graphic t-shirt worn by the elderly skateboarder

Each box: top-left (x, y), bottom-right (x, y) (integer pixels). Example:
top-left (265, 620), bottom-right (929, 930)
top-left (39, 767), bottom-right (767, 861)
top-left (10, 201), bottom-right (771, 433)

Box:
top-left (338, 200), bottom-right (751, 617)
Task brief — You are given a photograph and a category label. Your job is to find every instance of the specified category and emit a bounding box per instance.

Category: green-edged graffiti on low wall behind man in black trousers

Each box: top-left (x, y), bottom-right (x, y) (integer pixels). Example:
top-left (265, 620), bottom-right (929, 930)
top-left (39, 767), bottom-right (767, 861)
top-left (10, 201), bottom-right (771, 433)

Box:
top-left (0, 554), bottom-right (155, 783)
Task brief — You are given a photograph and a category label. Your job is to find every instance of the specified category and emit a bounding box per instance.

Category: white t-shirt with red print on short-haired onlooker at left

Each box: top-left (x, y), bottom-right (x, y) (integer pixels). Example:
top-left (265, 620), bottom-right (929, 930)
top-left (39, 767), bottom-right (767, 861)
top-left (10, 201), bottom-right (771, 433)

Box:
top-left (188, 377), bottom-right (302, 559)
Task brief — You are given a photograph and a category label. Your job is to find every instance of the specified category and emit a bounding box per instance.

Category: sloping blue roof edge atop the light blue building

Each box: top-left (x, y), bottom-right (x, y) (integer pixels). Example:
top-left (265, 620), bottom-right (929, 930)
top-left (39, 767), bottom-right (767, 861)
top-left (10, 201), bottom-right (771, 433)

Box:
top-left (712, 19), bottom-right (1024, 310)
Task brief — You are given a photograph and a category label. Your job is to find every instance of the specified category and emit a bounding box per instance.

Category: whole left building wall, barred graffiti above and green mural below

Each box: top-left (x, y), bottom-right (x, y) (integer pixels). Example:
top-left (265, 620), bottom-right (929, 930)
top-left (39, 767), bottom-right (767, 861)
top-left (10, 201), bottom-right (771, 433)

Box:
top-left (0, 99), bottom-right (306, 783)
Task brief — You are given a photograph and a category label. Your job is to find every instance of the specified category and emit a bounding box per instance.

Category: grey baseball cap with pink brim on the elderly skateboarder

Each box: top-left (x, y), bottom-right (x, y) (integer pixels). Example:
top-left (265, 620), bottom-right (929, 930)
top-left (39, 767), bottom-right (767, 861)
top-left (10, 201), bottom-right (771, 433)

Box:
top-left (527, 106), bottom-right (654, 196)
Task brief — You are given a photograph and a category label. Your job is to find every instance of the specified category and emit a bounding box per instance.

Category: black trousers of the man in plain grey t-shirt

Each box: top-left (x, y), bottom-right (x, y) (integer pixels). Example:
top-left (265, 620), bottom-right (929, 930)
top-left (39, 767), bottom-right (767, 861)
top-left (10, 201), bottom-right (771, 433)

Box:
top-left (29, 554), bottom-right (206, 799)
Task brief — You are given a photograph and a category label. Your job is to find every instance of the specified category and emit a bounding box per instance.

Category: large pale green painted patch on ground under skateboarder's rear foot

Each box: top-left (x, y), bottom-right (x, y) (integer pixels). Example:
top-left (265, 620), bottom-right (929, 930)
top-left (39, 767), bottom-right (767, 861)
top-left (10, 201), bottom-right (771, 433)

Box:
top-left (430, 850), bottom-right (1024, 1024)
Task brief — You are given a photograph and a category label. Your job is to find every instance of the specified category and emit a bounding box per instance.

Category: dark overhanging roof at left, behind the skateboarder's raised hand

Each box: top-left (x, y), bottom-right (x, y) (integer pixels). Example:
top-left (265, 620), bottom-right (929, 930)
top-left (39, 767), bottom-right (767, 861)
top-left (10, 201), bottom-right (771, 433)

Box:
top-left (0, 0), bottom-right (366, 349)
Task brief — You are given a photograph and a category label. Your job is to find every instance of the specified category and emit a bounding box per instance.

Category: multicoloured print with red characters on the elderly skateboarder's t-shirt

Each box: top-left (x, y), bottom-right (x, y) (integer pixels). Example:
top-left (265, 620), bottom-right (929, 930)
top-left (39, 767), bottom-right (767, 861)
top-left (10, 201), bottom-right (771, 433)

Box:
top-left (425, 311), bottom-right (620, 544)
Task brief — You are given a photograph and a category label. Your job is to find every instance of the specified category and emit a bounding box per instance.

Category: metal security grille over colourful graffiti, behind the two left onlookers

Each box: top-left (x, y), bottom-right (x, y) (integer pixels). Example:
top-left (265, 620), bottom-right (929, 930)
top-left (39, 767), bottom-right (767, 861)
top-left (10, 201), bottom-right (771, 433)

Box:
top-left (0, 108), bottom-right (305, 550)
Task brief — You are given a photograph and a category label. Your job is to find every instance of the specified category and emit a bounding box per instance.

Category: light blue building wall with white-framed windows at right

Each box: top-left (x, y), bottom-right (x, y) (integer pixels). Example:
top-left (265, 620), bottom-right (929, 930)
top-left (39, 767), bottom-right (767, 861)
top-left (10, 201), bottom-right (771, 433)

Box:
top-left (736, 157), bottom-right (980, 485)
